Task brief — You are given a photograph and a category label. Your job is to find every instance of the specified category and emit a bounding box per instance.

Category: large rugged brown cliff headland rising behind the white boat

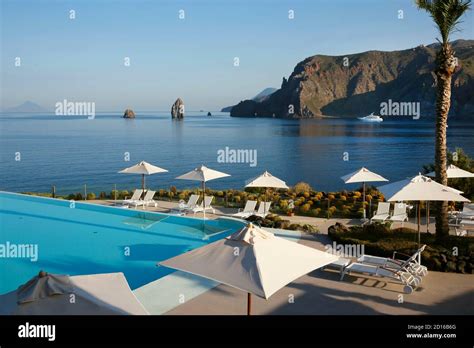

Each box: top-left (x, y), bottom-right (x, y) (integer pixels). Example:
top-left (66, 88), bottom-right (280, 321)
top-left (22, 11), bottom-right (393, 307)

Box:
top-left (228, 40), bottom-right (474, 118)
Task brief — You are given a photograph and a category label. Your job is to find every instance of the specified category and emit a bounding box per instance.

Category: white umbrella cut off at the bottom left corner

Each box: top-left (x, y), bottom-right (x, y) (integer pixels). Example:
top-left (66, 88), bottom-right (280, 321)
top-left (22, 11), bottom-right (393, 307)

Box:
top-left (0, 272), bottom-right (149, 315)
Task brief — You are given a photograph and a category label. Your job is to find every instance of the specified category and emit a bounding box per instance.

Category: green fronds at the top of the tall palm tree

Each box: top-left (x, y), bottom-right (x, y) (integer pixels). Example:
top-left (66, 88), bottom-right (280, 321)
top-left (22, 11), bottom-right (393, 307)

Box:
top-left (415, 0), bottom-right (471, 44)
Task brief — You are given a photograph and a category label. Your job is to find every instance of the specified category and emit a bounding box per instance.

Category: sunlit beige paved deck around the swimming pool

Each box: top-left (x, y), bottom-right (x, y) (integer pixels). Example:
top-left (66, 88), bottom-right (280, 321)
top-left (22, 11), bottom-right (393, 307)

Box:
top-left (91, 201), bottom-right (474, 315)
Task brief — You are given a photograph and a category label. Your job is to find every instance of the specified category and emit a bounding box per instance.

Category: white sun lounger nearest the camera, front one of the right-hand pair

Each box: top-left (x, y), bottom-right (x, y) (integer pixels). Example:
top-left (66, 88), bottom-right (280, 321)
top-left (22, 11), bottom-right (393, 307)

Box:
top-left (341, 260), bottom-right (421, 294)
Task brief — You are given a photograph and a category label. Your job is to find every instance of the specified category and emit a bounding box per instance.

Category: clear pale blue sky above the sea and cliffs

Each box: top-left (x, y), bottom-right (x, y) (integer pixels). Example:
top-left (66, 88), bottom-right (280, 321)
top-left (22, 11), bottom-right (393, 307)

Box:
top-left (0, 0), bottom-right (474, 111)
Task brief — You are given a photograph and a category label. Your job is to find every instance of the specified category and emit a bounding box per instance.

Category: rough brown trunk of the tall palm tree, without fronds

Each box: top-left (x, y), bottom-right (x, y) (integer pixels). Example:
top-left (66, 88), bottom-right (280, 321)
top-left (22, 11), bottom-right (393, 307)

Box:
top-left (435, 44), bottom-right (456, 240)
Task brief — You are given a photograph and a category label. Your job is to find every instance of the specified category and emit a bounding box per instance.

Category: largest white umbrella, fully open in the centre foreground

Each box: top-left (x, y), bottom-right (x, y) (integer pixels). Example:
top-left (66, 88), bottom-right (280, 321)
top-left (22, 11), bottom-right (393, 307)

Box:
top-left (159, 223), bottom-right (338, 314)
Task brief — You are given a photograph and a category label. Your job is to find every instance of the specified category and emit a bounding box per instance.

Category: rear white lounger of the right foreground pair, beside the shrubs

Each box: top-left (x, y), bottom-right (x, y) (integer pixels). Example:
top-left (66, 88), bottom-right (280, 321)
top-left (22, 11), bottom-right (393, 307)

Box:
top-left (357, 245), bottom-right (428, 277)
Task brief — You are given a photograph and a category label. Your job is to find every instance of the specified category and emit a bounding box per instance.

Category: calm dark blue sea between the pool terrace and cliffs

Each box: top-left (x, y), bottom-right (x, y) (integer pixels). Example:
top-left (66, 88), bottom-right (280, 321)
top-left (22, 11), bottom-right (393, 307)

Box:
top-left (0, 112), bottom-right (474, 193)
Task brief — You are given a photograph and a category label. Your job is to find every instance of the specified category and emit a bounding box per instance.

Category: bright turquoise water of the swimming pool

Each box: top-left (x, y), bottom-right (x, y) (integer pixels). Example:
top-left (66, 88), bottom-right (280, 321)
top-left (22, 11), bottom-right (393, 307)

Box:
top-left (0, 192), bottom-right (243, 294)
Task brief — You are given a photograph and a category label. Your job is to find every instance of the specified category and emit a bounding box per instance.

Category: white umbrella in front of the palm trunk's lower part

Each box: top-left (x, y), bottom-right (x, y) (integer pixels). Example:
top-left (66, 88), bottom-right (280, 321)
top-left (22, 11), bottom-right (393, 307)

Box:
top-left (378, 174), bottom-right (469, 256)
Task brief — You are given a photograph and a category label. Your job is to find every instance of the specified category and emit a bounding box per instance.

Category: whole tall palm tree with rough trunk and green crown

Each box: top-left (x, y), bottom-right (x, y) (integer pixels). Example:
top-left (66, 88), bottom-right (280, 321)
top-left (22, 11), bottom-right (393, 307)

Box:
top-left (415, 0), bottom-right (471, 239)
